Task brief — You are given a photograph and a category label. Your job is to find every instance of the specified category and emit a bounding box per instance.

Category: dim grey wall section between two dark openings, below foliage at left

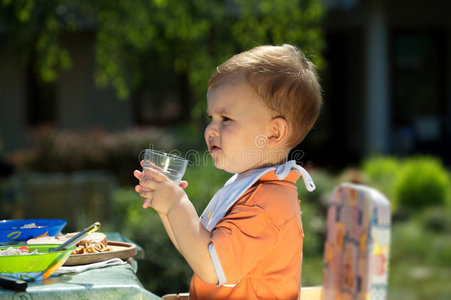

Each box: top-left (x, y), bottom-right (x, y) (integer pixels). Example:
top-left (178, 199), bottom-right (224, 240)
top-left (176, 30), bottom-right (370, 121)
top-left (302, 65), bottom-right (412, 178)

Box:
top-left (56, 33), bottom-right (133, 131)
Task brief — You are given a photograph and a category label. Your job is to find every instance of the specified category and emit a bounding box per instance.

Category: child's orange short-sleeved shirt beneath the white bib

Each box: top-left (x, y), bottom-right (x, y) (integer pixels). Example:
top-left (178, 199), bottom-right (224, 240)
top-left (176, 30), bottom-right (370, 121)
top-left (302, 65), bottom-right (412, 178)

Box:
top-left (190, 171), bottom-right (304, 299)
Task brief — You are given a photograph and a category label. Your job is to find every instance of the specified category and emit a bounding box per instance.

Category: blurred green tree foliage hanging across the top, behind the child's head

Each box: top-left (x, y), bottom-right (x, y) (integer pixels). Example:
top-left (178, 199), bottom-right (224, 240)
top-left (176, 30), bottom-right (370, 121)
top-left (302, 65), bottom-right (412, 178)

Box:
top-left (0, 0), bottom-right (323, 122)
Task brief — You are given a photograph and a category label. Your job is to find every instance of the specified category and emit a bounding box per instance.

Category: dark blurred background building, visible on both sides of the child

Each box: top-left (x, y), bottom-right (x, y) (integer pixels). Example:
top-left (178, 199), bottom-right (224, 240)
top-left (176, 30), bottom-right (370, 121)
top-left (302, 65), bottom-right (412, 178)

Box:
top-left (0, 0), bottom-right (451, 165)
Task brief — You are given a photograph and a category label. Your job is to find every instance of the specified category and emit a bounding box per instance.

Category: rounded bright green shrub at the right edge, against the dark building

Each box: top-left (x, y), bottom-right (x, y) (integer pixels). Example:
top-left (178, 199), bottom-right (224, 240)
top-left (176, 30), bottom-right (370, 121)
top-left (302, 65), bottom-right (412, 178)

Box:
top-left (393, 157), bottom-right (451, 210)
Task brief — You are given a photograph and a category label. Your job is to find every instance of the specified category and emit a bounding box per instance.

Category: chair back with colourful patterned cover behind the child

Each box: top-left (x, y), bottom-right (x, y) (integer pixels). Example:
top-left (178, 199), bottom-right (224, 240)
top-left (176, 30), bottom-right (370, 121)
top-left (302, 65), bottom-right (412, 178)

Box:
top-left (323, 183), bottom-right (391, 300)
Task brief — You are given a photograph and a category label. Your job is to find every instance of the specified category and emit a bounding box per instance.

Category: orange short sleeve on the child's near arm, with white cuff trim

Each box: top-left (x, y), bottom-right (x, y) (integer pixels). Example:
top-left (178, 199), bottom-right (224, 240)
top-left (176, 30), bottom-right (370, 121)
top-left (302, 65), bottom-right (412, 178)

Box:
top-left (210, 200), bottom-right (279, 285)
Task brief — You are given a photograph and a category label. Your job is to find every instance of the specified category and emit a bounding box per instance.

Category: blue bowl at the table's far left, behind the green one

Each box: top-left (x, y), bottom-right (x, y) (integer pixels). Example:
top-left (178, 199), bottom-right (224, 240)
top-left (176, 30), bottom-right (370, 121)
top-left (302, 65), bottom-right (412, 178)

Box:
top-left (0, 219), bottom-right (67, 243)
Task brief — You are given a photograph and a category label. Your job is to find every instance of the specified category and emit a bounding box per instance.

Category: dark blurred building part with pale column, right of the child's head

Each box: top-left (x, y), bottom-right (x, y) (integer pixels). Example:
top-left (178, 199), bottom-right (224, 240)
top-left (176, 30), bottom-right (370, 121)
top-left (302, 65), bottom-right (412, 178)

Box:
top-left (318, 0), bottom-right (451, 164)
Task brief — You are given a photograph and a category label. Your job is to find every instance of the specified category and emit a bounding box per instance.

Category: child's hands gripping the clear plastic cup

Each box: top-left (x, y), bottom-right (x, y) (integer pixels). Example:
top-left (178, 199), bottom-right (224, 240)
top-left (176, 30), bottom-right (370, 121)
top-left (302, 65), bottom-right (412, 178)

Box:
top-left (133, 168), bottom-right (188, 214)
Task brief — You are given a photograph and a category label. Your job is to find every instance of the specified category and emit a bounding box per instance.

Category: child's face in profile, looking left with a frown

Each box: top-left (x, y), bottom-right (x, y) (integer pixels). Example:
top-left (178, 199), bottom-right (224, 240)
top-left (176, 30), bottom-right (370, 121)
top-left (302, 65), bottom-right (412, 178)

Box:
top-left (205, 83), bottom-right (272, 173)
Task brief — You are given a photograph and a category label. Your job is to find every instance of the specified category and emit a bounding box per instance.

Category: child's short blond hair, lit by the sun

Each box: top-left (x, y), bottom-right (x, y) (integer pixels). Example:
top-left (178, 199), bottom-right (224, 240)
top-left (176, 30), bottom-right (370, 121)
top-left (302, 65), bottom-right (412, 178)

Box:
top-left (208, 44), bottom-right (322, 148)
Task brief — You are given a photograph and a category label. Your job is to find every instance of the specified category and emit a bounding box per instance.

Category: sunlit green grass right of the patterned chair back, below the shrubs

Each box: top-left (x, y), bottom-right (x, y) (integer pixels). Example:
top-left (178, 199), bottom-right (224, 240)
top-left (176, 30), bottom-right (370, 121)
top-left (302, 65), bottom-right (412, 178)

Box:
top-left (388, 212), bottom-right (451, 300)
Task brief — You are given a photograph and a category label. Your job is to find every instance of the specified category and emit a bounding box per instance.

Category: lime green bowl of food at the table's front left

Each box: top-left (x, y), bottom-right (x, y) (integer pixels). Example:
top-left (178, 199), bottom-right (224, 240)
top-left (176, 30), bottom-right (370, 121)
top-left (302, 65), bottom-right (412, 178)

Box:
top-left (0, 244), bottom-right (75, 281)
